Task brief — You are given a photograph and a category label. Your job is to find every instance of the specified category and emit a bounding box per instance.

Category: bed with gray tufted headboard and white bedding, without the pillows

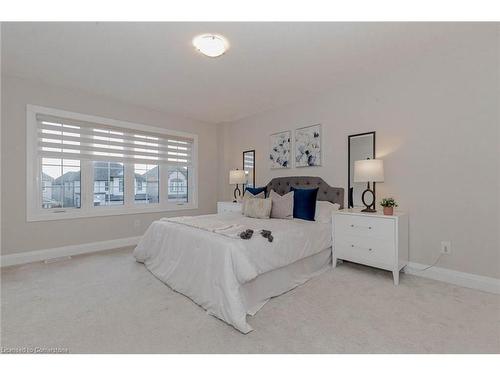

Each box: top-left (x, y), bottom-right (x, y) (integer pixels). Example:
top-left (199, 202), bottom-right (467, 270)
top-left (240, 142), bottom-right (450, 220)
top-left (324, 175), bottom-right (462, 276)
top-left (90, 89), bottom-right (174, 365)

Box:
top-left (134, 177), bottom-right (344, 333)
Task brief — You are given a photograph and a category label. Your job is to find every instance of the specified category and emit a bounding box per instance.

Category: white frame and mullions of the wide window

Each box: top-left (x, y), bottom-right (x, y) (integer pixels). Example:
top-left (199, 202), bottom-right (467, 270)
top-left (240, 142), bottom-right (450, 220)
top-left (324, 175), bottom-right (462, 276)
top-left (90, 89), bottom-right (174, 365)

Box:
top-left (26, 104), bottom-right (198, 222)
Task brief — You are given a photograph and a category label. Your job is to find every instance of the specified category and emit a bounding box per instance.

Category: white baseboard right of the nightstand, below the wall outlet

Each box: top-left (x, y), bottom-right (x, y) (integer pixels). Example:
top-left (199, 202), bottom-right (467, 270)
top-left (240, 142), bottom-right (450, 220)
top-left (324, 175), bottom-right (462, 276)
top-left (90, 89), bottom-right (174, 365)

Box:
top-left (404, 262), bottom-right (500, 294)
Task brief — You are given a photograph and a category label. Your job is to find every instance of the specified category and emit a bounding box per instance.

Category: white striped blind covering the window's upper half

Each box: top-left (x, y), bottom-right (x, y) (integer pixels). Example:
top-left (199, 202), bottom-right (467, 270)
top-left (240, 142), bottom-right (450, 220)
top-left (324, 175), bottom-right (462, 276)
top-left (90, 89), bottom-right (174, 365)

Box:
top-left (36, 114), bottom-right (193, 166)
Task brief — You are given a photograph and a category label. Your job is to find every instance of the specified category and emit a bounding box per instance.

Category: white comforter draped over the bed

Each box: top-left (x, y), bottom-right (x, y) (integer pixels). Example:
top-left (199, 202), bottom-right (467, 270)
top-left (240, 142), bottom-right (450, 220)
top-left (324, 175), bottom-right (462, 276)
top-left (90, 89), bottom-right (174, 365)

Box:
top-left (134, 213), bottom-right (332, 333)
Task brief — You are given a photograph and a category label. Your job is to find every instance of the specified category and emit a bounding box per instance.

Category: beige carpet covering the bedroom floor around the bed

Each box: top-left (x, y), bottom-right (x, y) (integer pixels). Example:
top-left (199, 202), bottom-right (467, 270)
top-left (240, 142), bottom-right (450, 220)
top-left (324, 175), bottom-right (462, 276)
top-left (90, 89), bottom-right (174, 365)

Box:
top-left (1, 248), bottom-right (500, 353)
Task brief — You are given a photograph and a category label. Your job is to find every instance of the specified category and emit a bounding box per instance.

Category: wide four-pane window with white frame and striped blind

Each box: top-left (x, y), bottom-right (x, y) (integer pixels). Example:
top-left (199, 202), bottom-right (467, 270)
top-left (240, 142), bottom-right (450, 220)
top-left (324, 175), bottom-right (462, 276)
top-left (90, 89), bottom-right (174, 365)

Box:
top-left (27, 106), bottom-right (197, 221)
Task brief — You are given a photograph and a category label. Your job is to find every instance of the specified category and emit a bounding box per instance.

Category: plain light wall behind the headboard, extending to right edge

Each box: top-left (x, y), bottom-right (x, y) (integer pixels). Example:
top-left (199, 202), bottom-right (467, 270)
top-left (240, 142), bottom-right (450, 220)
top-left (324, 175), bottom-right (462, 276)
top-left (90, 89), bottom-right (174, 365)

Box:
top-left (219, 25), bottom-right (500, 278)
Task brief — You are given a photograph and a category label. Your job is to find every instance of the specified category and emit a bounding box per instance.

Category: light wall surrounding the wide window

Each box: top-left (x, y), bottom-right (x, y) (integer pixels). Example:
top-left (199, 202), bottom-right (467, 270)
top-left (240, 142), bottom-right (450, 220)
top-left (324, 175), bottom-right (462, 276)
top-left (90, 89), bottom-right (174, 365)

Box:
top-left (1, 76), bottom-right (218, 254)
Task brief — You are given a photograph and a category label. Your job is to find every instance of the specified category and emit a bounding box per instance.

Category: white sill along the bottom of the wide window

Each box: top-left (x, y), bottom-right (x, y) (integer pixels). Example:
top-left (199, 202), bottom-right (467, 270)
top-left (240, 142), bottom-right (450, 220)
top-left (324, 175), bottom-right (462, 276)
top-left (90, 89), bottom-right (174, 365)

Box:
top-left (26, 204), bottom-right (198, 222)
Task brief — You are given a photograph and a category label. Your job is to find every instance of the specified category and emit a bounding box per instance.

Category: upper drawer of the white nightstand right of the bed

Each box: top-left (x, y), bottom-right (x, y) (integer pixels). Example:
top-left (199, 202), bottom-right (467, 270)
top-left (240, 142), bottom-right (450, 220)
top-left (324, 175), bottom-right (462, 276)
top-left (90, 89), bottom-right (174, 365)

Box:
top-left (335, 214), bottom-right (394, 241)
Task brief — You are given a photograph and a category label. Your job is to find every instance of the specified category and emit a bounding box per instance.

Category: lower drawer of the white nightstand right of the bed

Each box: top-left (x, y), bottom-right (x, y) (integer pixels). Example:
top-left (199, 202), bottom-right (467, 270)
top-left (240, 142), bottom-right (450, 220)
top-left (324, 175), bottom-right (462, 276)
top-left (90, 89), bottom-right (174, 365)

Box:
top-left (334, 236), bottom-right (396, 265)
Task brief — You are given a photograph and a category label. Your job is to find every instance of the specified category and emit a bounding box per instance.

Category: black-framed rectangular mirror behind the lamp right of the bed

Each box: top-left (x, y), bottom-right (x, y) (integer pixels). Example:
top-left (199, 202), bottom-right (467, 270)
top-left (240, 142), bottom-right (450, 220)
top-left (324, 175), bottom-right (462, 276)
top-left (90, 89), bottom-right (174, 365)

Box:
top-left (347, 132), bottom-right (375, 208)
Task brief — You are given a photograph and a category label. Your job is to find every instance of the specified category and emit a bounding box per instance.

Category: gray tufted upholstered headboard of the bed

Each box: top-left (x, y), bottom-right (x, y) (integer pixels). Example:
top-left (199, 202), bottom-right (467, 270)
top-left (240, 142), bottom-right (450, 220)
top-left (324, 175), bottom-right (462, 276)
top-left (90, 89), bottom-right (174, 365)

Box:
top-left (266, 176), bottom-right (344, 208)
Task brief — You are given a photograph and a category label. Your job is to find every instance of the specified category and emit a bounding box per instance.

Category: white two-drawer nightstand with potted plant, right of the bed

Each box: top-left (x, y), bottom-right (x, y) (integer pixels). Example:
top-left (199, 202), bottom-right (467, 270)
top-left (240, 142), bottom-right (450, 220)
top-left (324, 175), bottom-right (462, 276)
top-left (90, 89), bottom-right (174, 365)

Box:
top-left (333, 209), bottom-right (408, 285)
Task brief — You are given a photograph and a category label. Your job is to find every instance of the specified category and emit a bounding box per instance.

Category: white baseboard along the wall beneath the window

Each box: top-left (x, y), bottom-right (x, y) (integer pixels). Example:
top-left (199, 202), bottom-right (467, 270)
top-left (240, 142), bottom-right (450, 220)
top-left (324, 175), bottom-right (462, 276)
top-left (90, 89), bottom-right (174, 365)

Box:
top-left (0, 236), bottom-right (141, 267)
